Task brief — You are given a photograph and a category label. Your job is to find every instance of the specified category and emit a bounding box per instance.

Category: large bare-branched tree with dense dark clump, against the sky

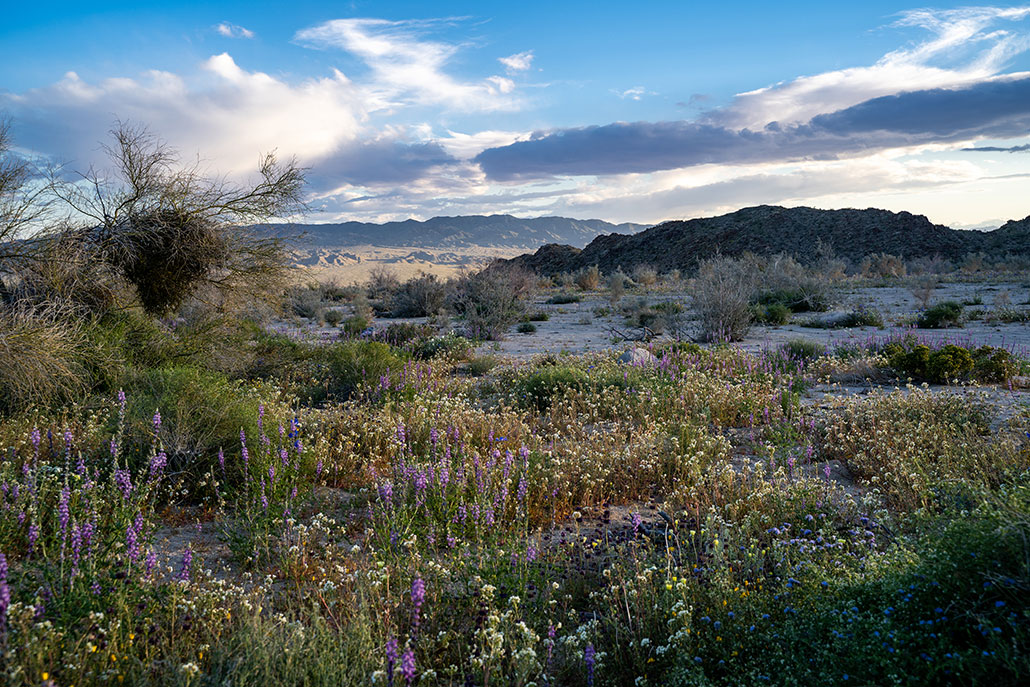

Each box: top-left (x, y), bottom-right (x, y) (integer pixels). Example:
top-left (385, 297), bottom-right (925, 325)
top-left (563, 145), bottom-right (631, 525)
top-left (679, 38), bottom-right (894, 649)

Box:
top-left (49, 125), bottom-right (304, 315)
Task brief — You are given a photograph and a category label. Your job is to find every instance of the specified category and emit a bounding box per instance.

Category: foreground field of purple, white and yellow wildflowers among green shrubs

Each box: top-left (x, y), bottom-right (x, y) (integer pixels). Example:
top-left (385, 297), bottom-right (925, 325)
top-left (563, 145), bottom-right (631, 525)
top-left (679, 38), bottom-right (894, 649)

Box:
top-left (0, 323), bottom-right (1030, 686)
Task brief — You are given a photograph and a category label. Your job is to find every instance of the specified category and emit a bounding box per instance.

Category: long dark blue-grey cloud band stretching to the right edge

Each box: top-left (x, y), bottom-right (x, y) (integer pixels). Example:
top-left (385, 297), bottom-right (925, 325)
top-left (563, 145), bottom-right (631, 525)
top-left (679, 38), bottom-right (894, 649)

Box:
top-left (475, 78), bottom-right (1030, 179)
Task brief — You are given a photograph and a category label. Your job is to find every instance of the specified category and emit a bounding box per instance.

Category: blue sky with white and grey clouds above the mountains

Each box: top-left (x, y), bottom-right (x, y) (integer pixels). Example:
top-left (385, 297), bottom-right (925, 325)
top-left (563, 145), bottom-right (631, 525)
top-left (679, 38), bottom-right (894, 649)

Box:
top-left (0, 0), bottom-right (1030, 227)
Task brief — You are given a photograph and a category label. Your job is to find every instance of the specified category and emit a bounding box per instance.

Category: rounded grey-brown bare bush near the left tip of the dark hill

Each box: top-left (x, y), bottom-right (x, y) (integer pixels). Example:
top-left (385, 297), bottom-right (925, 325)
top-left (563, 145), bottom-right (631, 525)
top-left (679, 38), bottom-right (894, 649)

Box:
top-left (451, 265), bottom-right (536, 340)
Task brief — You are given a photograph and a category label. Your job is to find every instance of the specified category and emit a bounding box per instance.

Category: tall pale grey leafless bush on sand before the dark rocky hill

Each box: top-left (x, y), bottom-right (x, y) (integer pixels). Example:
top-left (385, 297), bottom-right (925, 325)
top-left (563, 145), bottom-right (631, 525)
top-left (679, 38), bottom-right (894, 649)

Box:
top-left (691, 256), bottom-right (757, 341)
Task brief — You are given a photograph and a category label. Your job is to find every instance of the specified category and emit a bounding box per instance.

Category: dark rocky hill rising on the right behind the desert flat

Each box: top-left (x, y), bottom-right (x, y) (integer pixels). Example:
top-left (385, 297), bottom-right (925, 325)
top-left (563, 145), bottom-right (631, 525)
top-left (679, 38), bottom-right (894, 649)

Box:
top-left (500, 205), bottom-right (1030, 275)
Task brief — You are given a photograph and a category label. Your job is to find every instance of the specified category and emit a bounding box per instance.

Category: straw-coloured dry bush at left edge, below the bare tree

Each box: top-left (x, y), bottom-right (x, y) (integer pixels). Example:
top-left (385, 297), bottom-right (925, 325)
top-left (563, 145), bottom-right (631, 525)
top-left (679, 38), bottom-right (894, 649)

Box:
top-left (0, 306), bottom-right (88, 411)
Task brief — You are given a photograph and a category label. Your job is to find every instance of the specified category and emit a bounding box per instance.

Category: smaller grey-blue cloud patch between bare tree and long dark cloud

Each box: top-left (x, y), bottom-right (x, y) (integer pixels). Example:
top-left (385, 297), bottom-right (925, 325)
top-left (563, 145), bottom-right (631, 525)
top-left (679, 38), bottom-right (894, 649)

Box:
top-left (309, 139), bottom-right (458, 191)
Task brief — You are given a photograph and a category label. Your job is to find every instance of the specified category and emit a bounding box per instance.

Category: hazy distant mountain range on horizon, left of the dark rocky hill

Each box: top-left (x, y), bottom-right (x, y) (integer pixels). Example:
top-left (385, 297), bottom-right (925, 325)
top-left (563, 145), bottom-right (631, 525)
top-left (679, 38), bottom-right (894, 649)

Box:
top-left (277, 214), bottom-right (648, 249)
